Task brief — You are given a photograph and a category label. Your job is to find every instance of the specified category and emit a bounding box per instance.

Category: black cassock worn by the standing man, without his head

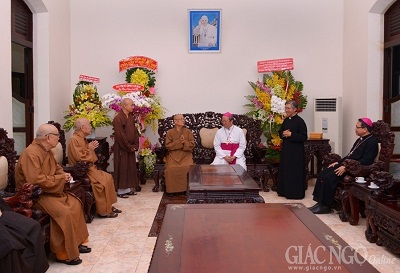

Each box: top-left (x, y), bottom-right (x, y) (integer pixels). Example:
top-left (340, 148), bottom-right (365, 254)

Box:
top-left (277, 115), bottom-right (307, 199)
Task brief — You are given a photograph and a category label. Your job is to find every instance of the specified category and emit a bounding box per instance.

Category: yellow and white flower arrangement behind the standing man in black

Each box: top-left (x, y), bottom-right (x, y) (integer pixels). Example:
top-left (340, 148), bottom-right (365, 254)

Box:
top-left (244, 70), bottom-right (307, 160)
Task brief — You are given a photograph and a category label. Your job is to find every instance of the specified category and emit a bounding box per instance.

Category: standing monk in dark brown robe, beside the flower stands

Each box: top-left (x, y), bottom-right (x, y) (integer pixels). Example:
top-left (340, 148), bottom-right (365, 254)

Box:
top-left (113, 98), bottom-right (140, 198)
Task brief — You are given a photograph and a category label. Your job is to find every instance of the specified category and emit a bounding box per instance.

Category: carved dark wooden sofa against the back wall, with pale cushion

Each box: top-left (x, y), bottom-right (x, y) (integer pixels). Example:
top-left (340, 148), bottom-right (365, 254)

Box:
top-left (153, 111), bottom-right (272, 191)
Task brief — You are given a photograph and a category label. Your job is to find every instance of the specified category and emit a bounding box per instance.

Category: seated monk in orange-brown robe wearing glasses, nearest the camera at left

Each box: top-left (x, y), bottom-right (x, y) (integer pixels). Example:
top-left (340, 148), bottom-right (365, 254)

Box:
top-left (15, 124), bottom-right (91, 265)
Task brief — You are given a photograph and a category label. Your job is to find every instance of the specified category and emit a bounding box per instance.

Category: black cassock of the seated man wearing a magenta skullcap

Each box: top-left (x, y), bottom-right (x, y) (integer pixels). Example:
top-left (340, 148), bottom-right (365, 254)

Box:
top-left (313, 135), bottom-right (379, 207)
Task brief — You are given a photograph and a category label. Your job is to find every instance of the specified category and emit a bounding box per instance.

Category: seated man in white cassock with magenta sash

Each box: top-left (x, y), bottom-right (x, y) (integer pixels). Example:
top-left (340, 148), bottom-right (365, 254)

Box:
top-left (211, 112), bottom-right (247, 170)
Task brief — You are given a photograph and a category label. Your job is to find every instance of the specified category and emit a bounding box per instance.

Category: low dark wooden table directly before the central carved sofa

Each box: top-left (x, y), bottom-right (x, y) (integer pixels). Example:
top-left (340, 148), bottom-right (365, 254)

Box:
top-left (187, 165), bottom-right (264, 204)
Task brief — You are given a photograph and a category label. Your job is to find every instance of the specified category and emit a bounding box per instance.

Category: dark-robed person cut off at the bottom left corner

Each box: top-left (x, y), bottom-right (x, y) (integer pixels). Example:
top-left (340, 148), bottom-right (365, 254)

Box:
top-left (0, 198), bottom-right (49, 273)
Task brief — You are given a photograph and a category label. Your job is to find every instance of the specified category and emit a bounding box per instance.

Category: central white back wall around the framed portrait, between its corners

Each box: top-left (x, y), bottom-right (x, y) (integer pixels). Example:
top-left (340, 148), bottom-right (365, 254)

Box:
top-left (71, 0), bottom-right (343, 144)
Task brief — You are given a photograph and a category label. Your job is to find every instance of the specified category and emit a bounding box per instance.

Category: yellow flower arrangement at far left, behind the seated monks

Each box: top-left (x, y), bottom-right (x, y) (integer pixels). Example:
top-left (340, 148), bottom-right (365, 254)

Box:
top-left (63, 81), bottom-right (111, 131)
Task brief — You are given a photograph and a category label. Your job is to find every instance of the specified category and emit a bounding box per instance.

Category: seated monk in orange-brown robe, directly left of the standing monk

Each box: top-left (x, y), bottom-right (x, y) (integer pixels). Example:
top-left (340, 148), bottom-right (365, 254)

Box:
top-left (68, 118), bottom-right (122, 218)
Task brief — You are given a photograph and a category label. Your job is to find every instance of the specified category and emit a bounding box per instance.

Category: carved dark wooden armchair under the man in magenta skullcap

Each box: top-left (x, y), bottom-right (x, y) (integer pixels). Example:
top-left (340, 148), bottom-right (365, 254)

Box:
top-left (324, 120), bottom-right (394, 222)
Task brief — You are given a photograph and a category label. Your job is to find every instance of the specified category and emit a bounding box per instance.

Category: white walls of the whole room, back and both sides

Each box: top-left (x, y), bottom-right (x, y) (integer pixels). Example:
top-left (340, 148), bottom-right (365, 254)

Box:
top-left (0, 0), bottom-right (393, 154)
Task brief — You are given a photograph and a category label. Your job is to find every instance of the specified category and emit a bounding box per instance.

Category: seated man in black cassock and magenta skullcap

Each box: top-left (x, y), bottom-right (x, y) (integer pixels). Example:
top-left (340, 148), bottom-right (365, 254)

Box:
top-left (310, 118), bottom-right (378, 214)
